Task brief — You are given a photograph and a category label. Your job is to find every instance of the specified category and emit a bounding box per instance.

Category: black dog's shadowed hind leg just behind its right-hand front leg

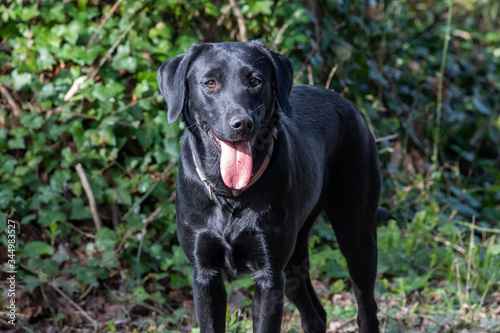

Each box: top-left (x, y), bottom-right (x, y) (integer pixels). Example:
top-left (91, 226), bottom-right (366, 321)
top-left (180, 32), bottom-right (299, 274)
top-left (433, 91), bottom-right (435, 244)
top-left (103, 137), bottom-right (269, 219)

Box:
top-left (285, 210), bottom-right (326, 333)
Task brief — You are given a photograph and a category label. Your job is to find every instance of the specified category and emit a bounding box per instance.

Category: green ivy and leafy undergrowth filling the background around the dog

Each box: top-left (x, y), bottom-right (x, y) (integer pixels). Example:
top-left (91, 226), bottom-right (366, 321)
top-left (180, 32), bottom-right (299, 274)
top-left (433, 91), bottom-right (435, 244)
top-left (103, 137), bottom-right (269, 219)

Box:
top-left (0, 0), bottom-right (500, 332)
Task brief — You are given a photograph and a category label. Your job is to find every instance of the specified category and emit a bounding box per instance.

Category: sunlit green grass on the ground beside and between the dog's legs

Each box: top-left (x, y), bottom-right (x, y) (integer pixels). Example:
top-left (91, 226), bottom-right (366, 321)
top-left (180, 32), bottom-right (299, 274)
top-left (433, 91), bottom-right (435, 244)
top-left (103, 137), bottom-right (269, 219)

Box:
top-left (110, 205), bottom-right (500, 333)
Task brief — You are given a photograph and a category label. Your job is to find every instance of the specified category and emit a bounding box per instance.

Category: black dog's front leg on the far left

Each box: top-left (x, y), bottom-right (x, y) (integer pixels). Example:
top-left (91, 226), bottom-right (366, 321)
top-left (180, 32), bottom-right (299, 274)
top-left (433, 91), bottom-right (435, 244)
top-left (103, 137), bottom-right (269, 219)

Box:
top-left (193, 268), bottom-right (227, 333)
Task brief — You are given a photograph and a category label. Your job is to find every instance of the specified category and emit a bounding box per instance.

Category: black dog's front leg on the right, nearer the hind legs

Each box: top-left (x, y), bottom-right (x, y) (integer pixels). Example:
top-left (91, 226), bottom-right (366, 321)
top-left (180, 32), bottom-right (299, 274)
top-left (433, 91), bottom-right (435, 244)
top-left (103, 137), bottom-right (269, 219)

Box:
top-left (252, 272), bottom-right (285, 333)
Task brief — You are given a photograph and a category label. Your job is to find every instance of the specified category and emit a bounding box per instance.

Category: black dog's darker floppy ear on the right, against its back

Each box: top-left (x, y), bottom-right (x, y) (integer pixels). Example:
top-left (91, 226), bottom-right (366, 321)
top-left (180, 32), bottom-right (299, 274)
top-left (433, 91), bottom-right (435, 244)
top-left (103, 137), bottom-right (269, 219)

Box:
top-left (270, 51), bottom-right (293, 118)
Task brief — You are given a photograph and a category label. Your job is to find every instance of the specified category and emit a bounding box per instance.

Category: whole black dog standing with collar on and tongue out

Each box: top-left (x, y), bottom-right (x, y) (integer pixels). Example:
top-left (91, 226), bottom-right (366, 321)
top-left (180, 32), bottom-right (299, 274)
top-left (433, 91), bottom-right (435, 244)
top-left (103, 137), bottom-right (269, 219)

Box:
top-left (158, 42), bottom-right (388, 333)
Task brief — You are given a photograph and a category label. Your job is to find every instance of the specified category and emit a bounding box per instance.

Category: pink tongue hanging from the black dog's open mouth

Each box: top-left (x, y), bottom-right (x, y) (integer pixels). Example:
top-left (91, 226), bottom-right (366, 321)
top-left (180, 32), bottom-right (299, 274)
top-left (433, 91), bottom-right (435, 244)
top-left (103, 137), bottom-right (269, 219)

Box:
top-left (220, 141), bottom-right (252, 190)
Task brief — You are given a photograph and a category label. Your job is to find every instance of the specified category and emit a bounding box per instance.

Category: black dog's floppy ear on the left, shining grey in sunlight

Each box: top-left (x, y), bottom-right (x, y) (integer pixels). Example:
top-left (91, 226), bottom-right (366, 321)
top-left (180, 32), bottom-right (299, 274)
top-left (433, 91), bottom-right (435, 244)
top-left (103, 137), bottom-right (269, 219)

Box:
top-left (158, 44), bottom-right (199, 124)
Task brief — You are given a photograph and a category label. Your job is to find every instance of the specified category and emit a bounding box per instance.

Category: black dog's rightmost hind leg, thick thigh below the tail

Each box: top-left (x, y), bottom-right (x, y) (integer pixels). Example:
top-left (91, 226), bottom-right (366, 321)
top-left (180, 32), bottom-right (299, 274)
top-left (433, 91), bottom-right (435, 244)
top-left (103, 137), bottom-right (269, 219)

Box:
top-left (323, 152), bottom-right (380, 333)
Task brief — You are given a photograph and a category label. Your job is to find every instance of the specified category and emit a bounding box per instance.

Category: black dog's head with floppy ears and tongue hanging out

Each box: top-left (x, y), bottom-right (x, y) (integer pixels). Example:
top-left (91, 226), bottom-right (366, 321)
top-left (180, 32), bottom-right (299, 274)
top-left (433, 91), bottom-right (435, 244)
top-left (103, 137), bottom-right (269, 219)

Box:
top-left (158, 41), bottom-right (293, 188)
